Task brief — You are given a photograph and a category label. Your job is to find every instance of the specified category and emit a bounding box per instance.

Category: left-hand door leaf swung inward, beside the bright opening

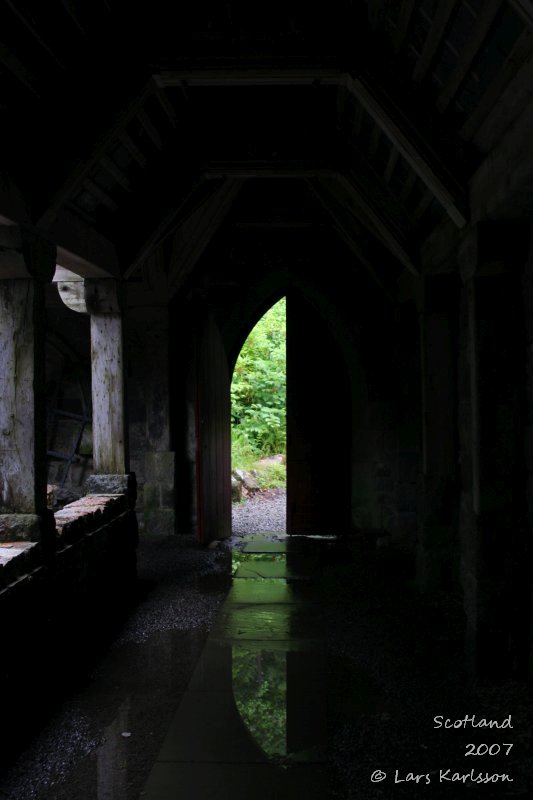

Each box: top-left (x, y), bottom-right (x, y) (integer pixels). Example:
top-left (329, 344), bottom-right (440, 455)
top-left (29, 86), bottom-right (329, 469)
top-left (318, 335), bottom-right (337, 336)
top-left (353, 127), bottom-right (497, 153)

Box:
top-left (196, 314), bottom-right (231, 544)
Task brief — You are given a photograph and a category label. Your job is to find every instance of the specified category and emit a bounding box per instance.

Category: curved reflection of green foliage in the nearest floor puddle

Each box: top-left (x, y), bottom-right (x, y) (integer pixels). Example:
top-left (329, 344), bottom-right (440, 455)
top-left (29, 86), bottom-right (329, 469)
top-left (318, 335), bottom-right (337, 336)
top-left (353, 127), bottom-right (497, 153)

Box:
top-left (232, 645), bottom-right (287, 756)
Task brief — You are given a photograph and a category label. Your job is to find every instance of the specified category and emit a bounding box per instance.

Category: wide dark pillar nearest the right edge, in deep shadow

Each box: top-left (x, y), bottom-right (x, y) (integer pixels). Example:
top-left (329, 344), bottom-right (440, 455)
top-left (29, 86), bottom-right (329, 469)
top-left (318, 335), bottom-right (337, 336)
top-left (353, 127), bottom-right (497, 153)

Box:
top-left (459, 222), bottom-right (530, 677)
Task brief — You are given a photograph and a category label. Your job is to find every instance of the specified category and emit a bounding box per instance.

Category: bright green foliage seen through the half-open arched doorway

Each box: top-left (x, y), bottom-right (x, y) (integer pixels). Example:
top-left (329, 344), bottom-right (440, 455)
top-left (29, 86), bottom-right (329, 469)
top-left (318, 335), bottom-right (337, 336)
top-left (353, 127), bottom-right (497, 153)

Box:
top-left (231, 298), bottom-right (286, 456)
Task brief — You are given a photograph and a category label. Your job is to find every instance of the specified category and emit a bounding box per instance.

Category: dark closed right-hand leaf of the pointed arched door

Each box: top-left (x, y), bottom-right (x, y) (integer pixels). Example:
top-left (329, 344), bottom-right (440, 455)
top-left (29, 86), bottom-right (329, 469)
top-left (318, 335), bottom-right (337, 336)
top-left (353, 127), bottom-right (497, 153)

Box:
top-left (287, 292), bottom-right (352, 534)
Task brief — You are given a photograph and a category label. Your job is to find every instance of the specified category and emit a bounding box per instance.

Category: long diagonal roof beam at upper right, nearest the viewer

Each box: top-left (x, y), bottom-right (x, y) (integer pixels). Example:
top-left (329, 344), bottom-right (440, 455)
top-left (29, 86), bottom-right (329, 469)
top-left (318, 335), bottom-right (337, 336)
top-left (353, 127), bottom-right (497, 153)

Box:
top-left (347, 78), bottom-right (466, 228)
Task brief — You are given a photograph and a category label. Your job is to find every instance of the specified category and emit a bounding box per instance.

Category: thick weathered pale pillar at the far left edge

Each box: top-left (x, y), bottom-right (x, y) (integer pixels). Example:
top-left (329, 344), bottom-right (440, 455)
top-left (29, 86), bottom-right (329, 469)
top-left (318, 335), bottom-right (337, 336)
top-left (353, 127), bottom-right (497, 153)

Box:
top-left (0, 226), bottom-right (55, 543)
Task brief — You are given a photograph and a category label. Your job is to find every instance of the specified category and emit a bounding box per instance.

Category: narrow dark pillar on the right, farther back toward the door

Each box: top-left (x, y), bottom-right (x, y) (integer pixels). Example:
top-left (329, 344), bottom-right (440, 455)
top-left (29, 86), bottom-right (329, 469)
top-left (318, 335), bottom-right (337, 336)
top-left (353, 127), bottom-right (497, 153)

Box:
top-left (417, 275), bottom-right (459, 591)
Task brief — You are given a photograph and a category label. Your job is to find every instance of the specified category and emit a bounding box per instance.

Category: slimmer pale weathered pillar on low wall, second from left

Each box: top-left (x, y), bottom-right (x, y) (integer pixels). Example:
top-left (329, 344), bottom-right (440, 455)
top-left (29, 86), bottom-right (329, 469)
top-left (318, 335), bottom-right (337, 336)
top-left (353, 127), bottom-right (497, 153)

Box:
top-left (58, 275), bottom-right (134, 500)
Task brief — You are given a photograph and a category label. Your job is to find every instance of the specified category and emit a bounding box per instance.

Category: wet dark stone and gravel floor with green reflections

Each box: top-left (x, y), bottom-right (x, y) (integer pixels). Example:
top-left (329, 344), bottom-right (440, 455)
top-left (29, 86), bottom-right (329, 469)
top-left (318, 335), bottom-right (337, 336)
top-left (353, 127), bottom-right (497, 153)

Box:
top-left (0, 534), bottom-right (533, 800)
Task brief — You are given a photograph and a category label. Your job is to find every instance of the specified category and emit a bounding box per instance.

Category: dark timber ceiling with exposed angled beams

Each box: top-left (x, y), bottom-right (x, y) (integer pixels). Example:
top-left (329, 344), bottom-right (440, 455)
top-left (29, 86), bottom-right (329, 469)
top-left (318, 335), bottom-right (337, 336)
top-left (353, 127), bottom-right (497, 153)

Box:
top-left (0, 0), bottom-right (533, 285)
